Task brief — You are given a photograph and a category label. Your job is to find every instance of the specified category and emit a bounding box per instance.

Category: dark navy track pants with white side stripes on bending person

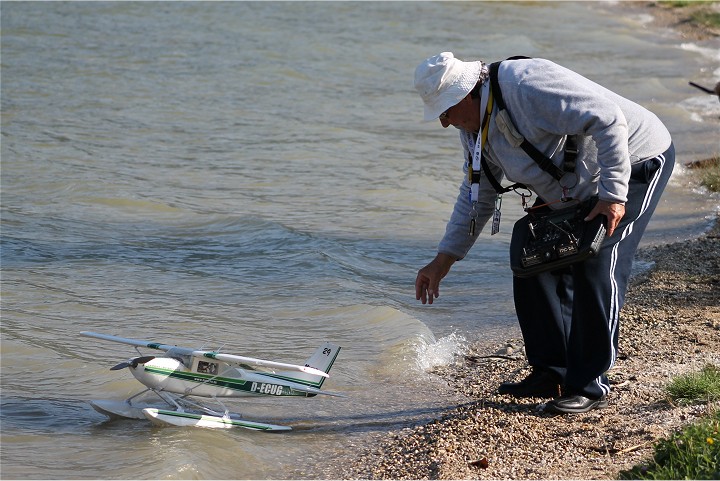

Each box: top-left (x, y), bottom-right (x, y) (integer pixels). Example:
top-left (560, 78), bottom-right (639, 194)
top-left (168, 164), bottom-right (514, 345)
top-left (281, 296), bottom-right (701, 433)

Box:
top-left (513, 145), bottom-right (675, 399)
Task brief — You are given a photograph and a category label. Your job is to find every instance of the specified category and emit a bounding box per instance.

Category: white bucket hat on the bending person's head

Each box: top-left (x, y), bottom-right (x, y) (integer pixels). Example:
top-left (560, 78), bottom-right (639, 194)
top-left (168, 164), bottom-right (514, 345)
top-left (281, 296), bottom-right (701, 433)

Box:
top-left (415, 52), bottom-right (482, 120)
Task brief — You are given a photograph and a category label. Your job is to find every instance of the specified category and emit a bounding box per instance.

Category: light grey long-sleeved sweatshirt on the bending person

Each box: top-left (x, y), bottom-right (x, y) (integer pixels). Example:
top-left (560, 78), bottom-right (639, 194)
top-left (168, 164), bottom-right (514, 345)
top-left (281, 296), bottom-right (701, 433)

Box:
top-left (438, 58), bottom-right (671, 259)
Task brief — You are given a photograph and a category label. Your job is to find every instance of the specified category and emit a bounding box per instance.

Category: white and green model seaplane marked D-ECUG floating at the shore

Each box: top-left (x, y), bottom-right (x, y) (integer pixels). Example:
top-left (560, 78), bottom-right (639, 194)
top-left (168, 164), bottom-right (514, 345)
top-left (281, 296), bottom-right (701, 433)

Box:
top-left (80, 331), bottom-right (344, 431)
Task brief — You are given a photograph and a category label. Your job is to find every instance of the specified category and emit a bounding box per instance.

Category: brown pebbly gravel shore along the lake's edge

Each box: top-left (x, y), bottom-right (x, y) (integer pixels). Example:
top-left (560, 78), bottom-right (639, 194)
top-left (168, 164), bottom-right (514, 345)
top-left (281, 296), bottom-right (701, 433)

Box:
top-left (326, 2), bottom-right (720, 479)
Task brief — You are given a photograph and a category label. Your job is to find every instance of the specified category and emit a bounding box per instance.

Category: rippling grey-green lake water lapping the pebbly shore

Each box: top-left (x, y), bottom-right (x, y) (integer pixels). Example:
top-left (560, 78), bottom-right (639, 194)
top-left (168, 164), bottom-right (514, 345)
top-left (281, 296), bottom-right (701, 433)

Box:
top-left (0, 2), bottom-right (720, 479)
